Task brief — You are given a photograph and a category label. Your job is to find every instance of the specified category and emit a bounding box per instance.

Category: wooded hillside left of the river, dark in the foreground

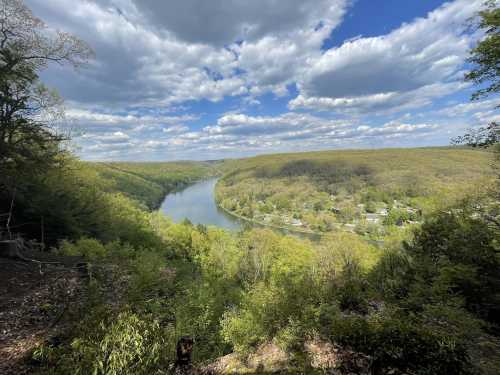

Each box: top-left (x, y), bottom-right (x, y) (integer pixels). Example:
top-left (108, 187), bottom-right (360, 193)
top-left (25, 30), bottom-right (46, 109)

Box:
top-left (0, 160), bottom-right (217, 246)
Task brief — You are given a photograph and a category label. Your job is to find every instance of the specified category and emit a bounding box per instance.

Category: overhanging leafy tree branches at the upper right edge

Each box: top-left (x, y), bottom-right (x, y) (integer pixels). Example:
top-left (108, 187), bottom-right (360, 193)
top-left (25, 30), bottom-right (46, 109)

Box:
top-left (465, 0), bottom-right (500, 100)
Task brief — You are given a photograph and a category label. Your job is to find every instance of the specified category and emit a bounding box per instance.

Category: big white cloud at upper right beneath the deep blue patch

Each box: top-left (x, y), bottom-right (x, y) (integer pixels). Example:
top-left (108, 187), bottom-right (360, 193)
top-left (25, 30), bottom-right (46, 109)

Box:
top-left (290, 0), bottom-right (483, 112)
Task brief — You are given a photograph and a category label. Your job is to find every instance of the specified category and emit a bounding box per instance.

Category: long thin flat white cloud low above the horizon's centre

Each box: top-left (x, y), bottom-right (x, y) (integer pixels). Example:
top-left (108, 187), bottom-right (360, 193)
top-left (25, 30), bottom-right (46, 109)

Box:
top-left (177, 113), bottom-right (437, 156)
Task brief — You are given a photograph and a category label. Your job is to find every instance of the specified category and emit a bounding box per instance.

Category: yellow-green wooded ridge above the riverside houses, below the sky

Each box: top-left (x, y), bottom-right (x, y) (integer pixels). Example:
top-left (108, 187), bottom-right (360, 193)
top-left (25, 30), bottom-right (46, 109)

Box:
top-left (224, 147), bottom-right (492, 198)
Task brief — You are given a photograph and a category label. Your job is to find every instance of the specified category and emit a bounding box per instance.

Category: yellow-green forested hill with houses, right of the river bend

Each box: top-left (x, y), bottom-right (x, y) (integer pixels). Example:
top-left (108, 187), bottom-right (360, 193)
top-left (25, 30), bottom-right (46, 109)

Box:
top-left (216, 148), bottom-right (494, 240)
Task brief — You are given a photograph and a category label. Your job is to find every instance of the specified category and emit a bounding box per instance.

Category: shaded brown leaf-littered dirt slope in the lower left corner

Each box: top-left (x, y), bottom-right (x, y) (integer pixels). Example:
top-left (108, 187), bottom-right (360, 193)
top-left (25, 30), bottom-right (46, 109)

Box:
top-left (0, 255), bottom-right (85, 375)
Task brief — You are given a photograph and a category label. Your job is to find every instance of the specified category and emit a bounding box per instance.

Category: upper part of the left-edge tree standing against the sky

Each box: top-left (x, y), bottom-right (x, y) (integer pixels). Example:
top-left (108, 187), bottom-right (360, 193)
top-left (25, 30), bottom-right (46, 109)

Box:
top-left (0, 0), bottom-right (92, 186)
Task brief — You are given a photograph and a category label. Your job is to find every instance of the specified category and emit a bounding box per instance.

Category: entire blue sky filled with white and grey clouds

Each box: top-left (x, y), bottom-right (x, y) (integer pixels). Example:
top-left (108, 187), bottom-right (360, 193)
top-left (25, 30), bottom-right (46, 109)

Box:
top-left (26, 0), bottom-right (500, 160)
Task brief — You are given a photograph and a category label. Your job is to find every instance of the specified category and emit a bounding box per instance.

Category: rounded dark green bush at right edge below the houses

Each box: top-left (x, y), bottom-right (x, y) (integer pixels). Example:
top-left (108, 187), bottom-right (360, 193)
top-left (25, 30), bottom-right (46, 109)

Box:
top-left (406, 210), bottom-right (500, 325)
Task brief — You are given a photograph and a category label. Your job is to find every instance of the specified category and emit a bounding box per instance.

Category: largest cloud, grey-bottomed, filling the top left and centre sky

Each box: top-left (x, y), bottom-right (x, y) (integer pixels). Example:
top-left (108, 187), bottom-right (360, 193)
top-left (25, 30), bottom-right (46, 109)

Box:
top-left (28, 0), bottom-right (348, 106)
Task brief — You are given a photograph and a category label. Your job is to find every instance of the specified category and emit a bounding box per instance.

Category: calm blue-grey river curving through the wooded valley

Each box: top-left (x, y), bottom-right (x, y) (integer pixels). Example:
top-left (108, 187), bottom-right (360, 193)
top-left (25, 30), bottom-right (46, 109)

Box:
top-left (160, 178), bottom-right (242, 231)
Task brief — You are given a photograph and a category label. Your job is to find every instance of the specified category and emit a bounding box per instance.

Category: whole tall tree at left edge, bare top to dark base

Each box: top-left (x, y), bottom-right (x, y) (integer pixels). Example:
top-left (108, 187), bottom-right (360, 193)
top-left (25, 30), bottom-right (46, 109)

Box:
top-left (0, 0), bottom-right (92, 241)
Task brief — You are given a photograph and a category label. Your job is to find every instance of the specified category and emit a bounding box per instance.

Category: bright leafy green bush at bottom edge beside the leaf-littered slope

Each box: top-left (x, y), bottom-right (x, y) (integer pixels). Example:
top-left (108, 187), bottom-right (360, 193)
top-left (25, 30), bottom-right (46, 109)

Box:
top-left (35, 312), bottom-right (175, 375)
